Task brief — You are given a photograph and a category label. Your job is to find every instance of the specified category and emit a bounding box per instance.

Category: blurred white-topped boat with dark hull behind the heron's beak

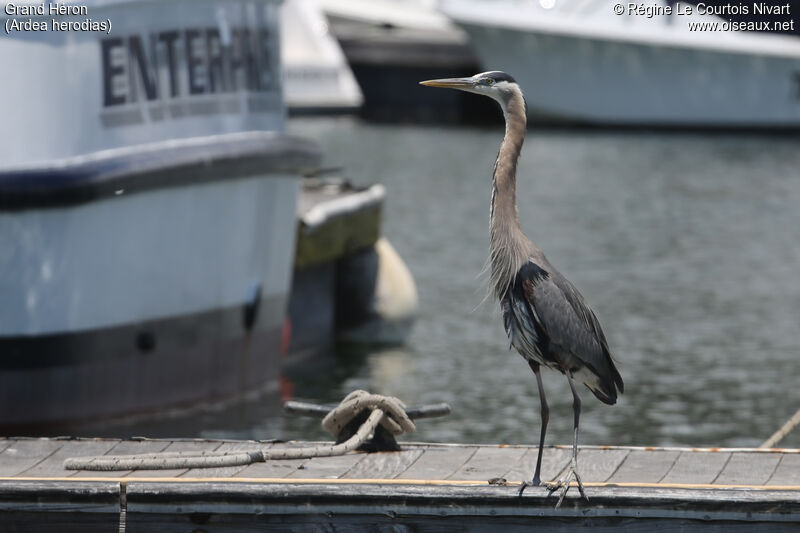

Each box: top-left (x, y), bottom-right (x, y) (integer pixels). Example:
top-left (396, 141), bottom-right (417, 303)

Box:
top-left (317, 0), bottom-right (496, 122)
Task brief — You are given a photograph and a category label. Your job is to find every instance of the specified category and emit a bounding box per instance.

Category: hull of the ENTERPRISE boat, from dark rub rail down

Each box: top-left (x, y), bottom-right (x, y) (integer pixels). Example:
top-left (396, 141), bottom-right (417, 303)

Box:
top-left (0, 133), bottom-right (319, 427)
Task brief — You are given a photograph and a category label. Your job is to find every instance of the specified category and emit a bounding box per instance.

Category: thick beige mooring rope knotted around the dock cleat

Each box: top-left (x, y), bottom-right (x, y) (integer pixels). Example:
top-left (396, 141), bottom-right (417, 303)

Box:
top-left (64, 390), bottom-right (416, 471)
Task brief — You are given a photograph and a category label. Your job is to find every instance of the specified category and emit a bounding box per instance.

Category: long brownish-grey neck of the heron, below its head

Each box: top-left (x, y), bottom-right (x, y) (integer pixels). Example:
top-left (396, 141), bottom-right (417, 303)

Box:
top-left (489, 91), bottom-right (531, 299)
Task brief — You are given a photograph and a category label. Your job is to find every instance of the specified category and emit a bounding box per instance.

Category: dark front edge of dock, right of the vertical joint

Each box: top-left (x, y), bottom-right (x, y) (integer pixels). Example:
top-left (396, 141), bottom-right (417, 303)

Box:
top-left (126, 480), bottom-right (800, 533)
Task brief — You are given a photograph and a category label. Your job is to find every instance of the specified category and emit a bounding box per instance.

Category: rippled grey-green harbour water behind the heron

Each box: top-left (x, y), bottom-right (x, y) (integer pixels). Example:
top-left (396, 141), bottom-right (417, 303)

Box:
top-left (117, 118), bottom-right (800, 446)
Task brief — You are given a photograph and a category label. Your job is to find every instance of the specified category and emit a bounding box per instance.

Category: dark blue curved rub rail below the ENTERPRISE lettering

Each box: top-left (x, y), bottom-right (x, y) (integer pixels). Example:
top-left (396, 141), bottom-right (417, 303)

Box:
top-left (0, 132), bottom-right (321, 211)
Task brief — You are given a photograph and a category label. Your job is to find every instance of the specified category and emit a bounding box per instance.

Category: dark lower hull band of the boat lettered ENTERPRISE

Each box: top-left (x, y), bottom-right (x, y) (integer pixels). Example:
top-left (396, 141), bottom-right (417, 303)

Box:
top-left (0, 306), bottom-right (286, 426)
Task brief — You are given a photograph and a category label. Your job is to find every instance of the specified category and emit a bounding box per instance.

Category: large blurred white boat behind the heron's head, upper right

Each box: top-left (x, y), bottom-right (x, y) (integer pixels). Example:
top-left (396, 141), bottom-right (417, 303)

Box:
top-left (441, 0), bottom-right (800, 127)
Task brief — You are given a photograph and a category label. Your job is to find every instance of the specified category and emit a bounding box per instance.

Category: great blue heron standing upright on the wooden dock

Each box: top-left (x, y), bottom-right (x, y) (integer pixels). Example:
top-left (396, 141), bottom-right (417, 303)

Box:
top-left (420, 71), bottom-right (624, 507)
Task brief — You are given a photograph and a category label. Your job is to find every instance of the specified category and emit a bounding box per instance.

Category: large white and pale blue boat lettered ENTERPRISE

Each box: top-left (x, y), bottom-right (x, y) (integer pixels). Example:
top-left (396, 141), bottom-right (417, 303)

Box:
top-left (0, 0), bottom-right (320, 428)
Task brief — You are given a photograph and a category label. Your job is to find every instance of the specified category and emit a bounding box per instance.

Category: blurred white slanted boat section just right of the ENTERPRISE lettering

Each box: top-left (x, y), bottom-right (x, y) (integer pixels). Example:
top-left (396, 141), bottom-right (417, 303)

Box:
top-left (281, 0), bottom-right (364, 113)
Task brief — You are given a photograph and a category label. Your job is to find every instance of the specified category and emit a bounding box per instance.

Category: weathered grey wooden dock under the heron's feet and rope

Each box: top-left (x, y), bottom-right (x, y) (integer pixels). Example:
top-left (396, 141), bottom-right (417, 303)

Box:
top-left (0, 438), bottom-right (800, 533)
